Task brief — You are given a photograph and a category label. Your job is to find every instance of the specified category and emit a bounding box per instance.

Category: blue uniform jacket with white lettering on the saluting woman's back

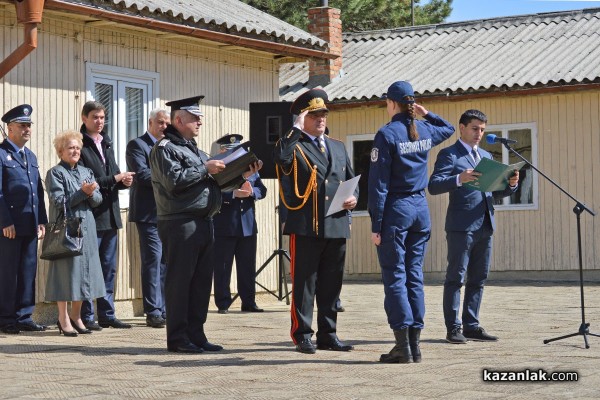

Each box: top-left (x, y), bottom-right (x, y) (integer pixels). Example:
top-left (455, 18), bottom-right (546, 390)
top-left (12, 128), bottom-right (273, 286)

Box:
top-left (368, 112), bottom-right (454, 233)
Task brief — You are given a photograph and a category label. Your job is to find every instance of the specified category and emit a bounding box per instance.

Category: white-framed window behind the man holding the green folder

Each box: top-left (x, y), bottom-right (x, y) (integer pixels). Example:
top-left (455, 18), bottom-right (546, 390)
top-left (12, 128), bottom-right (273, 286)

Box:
top-left (481, 124), bottom-right (538, 210)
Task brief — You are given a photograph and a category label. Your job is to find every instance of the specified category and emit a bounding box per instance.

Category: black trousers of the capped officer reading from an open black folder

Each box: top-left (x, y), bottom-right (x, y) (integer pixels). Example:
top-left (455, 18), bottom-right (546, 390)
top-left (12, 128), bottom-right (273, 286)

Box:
top-left (158, 217), bottom-right (214, 348)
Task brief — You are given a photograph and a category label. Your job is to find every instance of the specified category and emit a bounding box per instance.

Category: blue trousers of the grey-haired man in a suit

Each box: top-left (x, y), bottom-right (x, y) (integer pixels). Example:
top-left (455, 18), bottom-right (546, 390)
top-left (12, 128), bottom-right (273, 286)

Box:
top-left (135, 222), bottom-right (167, 317)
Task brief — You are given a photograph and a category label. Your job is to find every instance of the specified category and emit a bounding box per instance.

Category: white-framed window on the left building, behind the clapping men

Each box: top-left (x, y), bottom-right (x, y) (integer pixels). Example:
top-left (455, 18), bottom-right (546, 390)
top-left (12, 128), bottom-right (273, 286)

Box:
top-left (86, 63), bottom-right (159, 208)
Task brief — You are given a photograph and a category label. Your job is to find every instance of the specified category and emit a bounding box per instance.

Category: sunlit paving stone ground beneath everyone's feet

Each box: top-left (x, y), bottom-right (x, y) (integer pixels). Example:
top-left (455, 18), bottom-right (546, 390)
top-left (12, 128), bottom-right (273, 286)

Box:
top-left (0, 281), bottom-right (600, 400)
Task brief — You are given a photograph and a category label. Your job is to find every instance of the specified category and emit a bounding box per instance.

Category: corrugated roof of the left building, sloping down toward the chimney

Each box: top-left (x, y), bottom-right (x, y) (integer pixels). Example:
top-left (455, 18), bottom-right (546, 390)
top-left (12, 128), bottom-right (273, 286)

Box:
top-left (62, 0), bottom-right (327, 50)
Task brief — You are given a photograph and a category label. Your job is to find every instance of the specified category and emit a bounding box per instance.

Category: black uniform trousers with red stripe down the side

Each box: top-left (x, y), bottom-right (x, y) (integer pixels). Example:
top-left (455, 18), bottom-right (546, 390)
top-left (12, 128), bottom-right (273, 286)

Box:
top-left (290, 235), bottom-right (346, 344)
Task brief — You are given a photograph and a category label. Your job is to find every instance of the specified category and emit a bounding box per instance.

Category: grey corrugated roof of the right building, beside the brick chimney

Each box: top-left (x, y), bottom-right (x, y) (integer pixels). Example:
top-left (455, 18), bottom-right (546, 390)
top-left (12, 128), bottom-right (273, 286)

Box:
top-left (280, 8), bottom-right (600, 102)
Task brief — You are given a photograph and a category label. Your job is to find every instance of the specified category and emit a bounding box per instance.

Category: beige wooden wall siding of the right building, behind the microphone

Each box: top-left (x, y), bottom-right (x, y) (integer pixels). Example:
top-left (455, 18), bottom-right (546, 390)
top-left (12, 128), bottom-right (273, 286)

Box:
top-left (328, 90), bottom-right (600, 277)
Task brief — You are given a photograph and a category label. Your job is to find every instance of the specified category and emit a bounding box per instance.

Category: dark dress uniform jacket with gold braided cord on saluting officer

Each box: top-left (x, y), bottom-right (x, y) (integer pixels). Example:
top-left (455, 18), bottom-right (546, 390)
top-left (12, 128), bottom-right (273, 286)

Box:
top-left (274, 127), bottom-right (358, 239)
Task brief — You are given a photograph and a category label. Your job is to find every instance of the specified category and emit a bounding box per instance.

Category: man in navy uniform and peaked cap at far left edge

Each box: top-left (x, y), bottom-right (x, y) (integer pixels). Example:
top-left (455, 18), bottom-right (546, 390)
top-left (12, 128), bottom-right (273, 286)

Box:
top-left (0, 104), bottom-right (48, 334)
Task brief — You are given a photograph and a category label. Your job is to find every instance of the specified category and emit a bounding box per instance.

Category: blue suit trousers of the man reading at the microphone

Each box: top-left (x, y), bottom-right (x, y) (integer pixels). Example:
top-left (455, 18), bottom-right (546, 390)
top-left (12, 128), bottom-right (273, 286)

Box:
top-left (443, 222), bottom-right (493, 331)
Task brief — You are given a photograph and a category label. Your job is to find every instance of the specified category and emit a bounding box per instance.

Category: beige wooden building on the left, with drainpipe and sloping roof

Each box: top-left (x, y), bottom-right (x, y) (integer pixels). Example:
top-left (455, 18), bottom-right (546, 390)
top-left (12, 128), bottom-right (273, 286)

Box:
top-left (0, 0), bottom-right (335, 315)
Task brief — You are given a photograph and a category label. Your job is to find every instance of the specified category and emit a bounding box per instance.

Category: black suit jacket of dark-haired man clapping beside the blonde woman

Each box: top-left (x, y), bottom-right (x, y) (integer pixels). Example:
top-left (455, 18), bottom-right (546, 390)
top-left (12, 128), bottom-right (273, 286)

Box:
top-left (79, 125), bottom-right (126, 231)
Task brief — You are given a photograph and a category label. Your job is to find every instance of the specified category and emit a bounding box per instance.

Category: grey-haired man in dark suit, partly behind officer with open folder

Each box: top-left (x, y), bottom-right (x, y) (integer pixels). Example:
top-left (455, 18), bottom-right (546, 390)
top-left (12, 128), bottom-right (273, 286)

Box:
top-left (125, 109), bottom-right (171, 328)
